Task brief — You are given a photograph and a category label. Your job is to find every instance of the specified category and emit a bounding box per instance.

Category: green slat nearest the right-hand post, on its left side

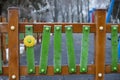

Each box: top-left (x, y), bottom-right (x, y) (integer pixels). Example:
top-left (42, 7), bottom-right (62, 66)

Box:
top-left (80, 25), bottom-right (90, 72)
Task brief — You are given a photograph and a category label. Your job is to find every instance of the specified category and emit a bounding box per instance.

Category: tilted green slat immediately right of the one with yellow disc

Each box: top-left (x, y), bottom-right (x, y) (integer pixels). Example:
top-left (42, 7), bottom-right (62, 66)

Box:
top-left (39, 25), bottom-right (51, 74)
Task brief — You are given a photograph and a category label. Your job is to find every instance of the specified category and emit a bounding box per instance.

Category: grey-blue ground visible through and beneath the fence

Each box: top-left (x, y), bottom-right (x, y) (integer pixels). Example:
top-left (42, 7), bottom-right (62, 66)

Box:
top-left (0, 34), bottom-right (120, 80)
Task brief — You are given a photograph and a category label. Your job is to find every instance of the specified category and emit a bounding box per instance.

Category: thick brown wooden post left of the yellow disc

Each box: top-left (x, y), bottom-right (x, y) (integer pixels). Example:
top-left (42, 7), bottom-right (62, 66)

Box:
top-left (8, 8), bottom-right (19, 80)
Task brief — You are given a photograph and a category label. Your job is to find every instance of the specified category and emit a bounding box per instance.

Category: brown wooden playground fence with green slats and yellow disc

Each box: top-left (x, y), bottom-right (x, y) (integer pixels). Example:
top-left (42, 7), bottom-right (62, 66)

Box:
top-left (0, 8), bottom-right (120, 80)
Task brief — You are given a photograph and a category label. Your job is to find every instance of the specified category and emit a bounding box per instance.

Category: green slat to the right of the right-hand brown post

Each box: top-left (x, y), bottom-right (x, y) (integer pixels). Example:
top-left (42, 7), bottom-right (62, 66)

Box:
top-left (111, 25), bottom-right (118, 71)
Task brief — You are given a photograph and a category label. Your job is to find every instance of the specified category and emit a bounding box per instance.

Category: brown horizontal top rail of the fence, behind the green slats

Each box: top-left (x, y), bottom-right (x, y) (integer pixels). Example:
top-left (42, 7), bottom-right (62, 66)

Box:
top-left (0, 22), bottom-right (120, 33)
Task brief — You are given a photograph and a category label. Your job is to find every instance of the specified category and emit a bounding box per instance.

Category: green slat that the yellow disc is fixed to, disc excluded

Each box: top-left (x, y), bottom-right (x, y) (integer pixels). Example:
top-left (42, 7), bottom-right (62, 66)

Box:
top-left (25, 25), bottom-right (35, 74)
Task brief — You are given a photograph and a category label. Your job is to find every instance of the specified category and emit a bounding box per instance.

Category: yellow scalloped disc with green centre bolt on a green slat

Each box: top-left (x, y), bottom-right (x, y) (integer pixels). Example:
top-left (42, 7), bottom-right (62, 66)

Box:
top-left (24, 35), bottom-right (36, 47)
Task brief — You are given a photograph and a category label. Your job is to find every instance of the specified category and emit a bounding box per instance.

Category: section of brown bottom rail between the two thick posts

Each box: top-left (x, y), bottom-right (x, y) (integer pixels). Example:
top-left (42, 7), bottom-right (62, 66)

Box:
top-left (20, 65), bottom-right (95, 76)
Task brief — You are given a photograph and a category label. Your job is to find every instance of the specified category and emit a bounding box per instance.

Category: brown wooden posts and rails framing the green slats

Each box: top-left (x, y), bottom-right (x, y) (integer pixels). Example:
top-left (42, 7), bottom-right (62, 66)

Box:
top-left (0, 8), bottom-right (120, 80)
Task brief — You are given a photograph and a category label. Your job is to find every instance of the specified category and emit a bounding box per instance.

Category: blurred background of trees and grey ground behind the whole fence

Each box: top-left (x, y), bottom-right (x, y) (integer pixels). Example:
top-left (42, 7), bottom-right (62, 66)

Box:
top-left (0, 0), bottom-right (120, 80)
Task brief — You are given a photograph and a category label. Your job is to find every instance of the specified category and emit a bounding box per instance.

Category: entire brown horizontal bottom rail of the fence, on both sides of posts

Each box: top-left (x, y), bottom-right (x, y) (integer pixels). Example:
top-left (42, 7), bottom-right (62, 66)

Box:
top-left (0, 64), bottom-right (120, 76)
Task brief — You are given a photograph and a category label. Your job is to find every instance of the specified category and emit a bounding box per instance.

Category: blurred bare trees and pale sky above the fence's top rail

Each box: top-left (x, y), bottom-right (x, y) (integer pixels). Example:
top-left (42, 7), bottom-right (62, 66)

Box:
top-left (0, 0), bottom-right (120, 23)
